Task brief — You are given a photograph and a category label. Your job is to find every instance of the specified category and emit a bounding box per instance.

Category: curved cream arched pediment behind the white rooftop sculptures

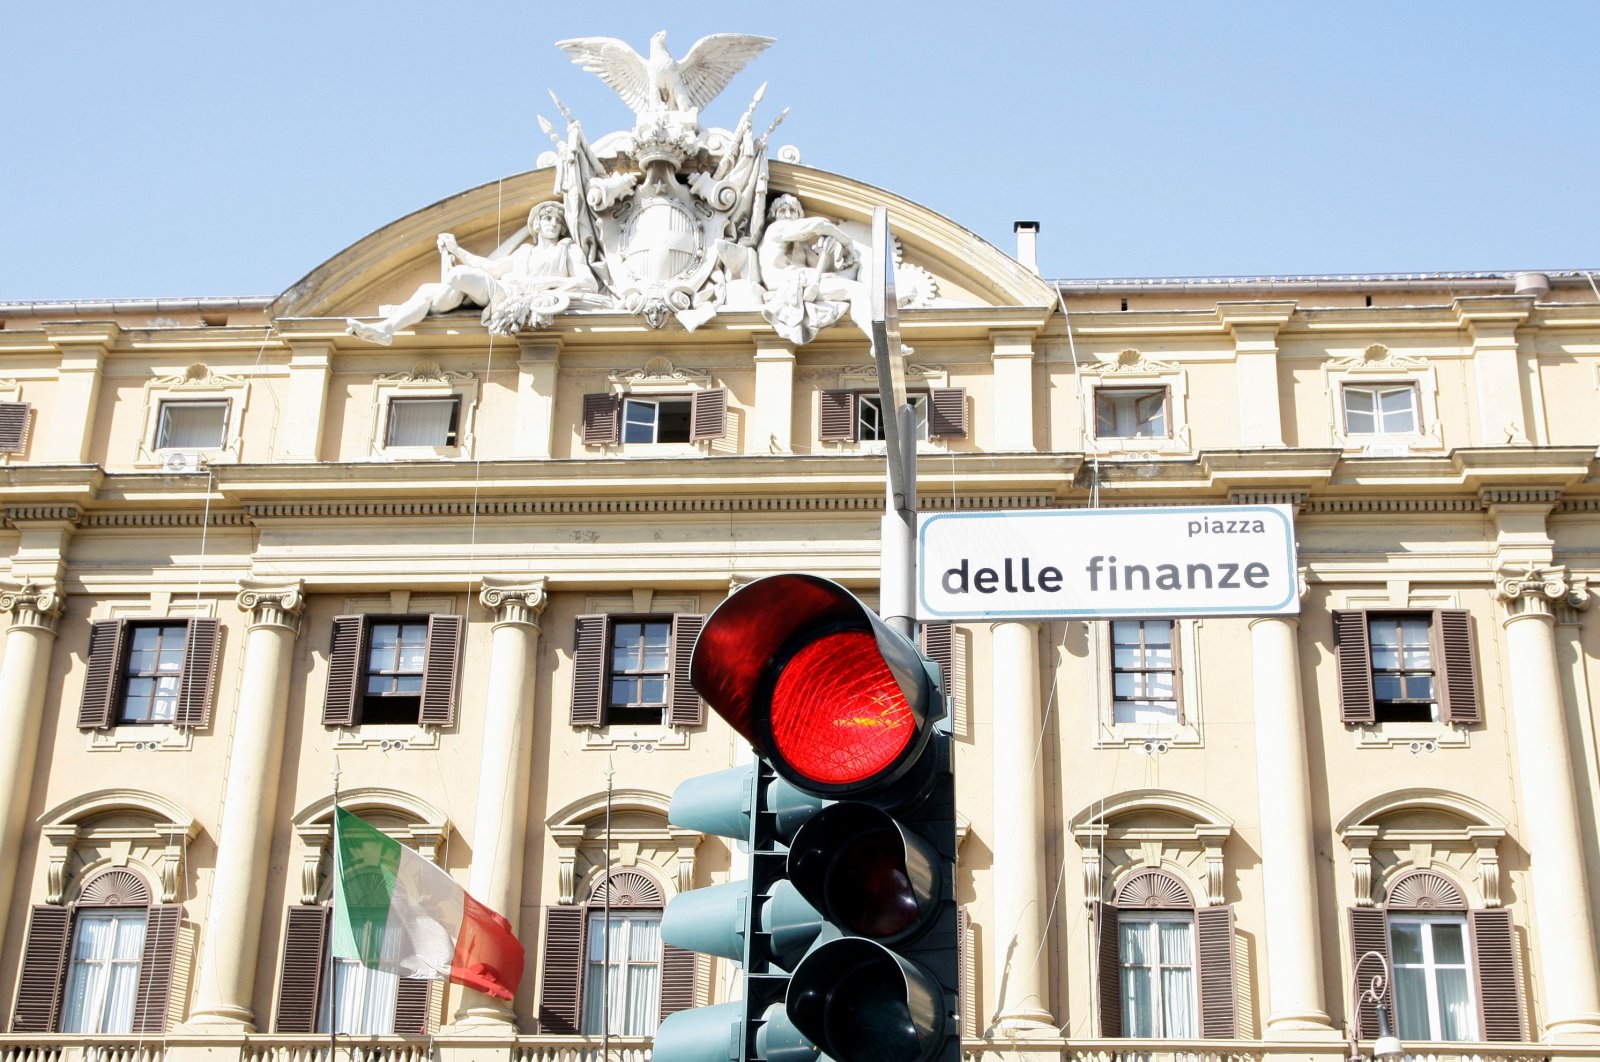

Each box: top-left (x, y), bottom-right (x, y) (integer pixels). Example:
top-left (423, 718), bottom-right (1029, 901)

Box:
top-left (269, 162), bottom-right (1054, 328)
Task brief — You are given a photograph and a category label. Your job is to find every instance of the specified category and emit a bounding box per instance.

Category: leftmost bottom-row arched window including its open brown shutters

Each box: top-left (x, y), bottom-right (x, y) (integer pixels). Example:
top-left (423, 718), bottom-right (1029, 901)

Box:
top-left (11, 867), bottom-right (182, 1033)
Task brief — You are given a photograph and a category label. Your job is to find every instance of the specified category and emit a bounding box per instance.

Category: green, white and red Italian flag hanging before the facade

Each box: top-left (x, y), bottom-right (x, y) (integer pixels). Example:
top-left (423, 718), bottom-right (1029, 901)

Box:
top-left (333, 808), bottom-right (523, 1000)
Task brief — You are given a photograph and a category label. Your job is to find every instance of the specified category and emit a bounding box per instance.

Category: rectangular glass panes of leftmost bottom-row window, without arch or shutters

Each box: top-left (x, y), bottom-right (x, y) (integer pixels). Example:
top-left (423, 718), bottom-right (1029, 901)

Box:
top-left (58, 908), bottom-right (146, 1033)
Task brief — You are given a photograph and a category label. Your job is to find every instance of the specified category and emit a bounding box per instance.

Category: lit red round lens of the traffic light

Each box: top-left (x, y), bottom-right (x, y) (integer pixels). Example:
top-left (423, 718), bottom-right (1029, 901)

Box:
top-left (770, 630), bottom-right (917, 785)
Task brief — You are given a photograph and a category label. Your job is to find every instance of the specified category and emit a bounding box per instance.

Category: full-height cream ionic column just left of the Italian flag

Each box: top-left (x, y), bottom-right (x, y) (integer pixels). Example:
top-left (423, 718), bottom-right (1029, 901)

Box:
top-left (189, 581), bottom-right (306, 1032)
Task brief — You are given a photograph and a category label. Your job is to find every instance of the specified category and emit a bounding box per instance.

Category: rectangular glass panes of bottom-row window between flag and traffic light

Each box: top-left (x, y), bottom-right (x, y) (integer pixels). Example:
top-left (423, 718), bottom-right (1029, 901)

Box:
top-left (582, 910), bottom-right (661, 1036)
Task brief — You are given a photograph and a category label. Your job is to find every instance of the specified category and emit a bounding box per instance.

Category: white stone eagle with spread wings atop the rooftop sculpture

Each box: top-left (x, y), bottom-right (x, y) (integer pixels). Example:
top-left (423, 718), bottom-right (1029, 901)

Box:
top-left (555, 30), bottom-right (773, 120)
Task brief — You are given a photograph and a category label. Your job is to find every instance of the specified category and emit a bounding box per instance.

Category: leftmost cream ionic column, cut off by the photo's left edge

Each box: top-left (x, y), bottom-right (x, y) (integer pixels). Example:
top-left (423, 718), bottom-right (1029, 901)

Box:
top-left (0, 581), bottom-right (61, 940)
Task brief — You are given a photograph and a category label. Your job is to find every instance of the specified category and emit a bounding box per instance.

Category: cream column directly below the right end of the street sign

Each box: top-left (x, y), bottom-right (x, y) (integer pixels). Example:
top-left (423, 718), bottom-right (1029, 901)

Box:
top-left (1250, 616), bottom-right (1333, 1040)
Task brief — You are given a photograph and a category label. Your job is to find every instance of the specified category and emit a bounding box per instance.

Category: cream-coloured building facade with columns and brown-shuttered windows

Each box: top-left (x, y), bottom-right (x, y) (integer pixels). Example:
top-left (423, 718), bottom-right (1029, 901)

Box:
top-left (0, 162), bottom-right (1600, 1062)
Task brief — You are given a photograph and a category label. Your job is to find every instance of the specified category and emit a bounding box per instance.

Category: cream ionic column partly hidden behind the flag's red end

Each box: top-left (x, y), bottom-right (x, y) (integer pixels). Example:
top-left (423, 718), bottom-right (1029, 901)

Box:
top-left (454, 579), bottom-right (546, 1033)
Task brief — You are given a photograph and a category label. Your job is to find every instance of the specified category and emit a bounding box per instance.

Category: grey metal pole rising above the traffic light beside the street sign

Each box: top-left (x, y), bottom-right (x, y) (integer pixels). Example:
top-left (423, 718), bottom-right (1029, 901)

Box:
top-left (872, 206), bottom-right (917, 638)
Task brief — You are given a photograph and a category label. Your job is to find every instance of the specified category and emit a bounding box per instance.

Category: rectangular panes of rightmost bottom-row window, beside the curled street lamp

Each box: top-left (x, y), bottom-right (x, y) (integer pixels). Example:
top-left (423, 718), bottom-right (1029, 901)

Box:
top-left (1389, 912), bottom-right (1478, 1041)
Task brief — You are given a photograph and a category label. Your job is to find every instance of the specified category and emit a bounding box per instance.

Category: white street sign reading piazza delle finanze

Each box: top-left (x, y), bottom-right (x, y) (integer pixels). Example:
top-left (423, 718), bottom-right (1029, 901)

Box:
top-left (917, 505), bottom-right (1299, 621)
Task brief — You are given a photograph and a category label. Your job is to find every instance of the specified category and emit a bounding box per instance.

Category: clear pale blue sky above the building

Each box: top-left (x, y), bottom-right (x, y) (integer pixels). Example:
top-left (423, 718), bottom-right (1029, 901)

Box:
top-left (0, 0), bottom-right (1600, 301)
